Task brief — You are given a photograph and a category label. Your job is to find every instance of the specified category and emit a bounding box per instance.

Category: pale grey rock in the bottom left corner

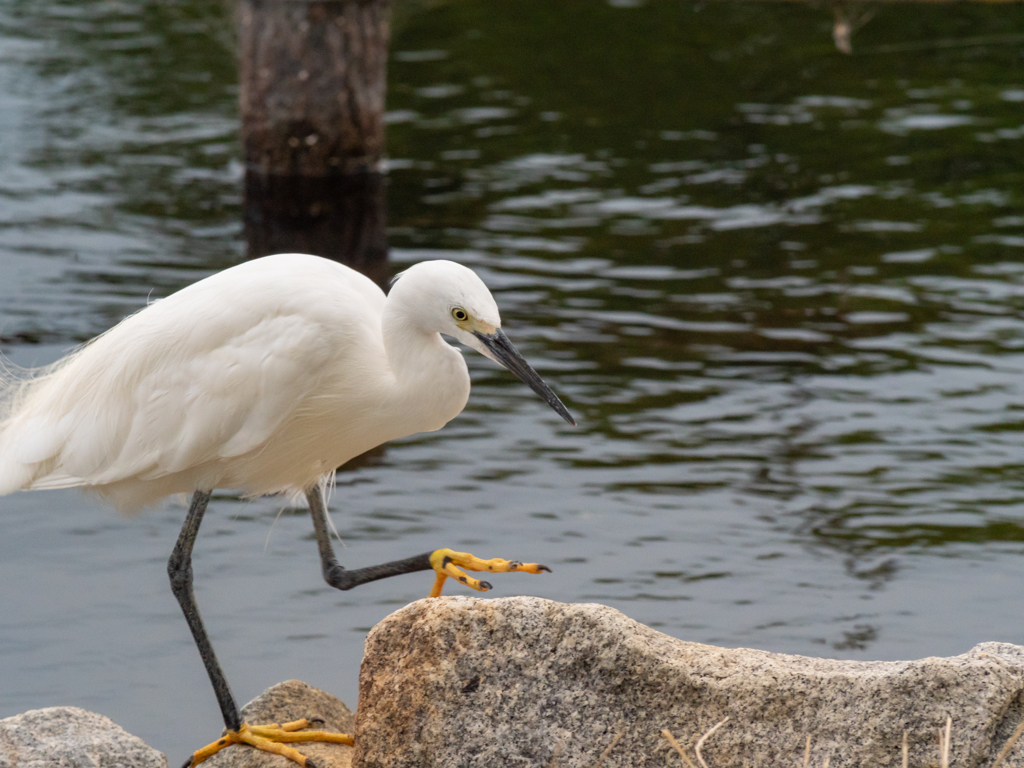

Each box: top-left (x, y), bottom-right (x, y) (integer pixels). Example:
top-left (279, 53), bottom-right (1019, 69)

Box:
top-left (0, 707), bottom-right (167, 768)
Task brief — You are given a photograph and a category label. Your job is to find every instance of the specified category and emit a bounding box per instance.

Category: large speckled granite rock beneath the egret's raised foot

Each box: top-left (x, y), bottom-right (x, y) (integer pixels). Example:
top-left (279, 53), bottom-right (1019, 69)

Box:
top-left (354, 597), bottom-right (1024, 768)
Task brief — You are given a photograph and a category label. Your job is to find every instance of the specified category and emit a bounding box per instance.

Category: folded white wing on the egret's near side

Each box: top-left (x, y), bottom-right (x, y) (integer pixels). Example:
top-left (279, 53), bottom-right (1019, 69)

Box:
top-left (12, 315), bottom-right (329, 487)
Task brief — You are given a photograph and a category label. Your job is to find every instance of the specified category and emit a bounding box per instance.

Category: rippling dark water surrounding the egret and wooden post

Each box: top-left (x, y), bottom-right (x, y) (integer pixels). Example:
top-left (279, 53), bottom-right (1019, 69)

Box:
top-left (0, 0), bottom-right (1024, 762)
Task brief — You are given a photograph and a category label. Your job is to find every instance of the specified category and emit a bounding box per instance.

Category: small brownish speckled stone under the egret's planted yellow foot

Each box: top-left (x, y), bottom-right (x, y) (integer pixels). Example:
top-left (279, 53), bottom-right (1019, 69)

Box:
top-left (200, 680), bottom-right (354, 768)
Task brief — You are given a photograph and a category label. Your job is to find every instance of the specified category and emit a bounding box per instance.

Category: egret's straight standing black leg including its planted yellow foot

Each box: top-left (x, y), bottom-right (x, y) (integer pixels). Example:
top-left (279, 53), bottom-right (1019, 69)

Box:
top-left (167, 490), bottom-right (352, 768)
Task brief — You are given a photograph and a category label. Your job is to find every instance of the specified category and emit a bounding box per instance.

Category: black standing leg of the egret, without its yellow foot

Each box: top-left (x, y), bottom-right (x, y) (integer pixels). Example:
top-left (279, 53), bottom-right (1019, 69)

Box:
top-left (167, 490), bottom-right (241, 731)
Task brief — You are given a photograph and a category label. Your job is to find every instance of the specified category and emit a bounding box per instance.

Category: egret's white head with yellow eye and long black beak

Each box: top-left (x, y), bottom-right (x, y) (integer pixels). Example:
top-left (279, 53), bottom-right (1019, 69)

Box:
top-left (391, 260), bottom-right (575, 426)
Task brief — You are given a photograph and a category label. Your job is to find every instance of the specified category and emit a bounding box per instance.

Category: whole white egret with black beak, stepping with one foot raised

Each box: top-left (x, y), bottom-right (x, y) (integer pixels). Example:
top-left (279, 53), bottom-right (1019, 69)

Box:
top-left (0, 254), bottom-right (575, 765)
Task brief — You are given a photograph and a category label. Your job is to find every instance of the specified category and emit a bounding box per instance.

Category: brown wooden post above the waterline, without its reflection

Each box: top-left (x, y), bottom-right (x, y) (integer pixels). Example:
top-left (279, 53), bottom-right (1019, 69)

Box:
top-left (239, 0), bottom-right (390, 176)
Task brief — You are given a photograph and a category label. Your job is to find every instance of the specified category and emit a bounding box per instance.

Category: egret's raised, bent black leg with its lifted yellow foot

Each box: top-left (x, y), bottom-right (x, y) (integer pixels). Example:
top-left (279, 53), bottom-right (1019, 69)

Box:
top-left (306, 486), bottom-right (551, 597)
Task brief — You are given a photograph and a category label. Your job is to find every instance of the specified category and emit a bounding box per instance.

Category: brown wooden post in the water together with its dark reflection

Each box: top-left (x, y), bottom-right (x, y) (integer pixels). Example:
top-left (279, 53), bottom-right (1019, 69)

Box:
top-left (239, 0), bottom-right (390, 284)
